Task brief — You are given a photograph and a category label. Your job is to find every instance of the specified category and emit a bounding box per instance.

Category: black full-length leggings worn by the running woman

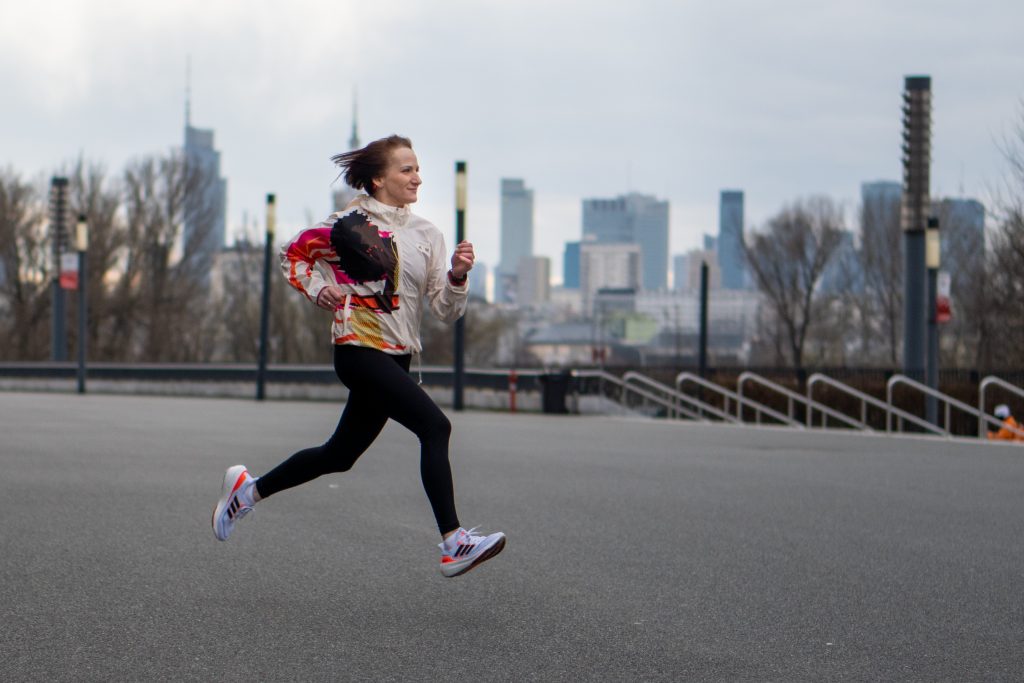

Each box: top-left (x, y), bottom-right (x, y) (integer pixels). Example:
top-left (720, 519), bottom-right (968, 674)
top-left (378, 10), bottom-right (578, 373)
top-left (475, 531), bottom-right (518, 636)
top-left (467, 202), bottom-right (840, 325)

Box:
top-left (256, 345), bottom-right (460, 533)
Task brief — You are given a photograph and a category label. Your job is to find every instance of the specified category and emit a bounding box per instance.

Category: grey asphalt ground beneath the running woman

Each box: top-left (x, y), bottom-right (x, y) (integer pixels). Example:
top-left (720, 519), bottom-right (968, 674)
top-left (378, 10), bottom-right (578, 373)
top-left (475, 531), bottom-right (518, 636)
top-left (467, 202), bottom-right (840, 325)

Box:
top-left (0, 393), bottom-right (1024, 681)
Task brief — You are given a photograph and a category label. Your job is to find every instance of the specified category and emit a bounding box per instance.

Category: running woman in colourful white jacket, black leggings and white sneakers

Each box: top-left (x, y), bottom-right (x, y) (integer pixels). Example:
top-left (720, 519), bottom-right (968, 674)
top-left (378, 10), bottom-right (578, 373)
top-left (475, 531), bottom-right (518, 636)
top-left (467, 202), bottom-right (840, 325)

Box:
top-left (213, 135), bottom-right (505, 577)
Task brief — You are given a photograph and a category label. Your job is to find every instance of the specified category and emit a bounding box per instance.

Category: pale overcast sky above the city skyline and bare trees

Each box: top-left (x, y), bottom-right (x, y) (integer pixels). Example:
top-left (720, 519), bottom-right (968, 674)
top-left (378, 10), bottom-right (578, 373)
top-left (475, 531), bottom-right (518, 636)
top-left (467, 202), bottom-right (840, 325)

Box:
top-left (0, 0), bottom-right (1024, 279)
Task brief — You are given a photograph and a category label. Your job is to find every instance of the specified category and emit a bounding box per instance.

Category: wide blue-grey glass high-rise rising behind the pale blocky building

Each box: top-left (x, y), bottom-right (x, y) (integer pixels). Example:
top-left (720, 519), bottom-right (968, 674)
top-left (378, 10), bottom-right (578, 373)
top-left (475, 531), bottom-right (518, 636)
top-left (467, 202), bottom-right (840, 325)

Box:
top-left (583, 193), bottom-right (669, 291)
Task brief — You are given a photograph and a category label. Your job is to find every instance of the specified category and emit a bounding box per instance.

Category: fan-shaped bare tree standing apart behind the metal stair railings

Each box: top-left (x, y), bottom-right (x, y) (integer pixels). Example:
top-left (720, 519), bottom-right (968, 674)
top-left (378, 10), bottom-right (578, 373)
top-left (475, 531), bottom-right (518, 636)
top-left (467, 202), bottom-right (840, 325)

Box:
top-left (743, 197), bottom-right (843, 377)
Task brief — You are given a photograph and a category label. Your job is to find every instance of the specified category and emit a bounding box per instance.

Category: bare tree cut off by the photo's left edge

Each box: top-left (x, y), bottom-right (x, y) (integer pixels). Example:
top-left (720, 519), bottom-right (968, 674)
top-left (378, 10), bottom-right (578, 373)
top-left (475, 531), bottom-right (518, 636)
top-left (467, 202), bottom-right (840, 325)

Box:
top-left (0, 169), bottom-right (47, 360)
